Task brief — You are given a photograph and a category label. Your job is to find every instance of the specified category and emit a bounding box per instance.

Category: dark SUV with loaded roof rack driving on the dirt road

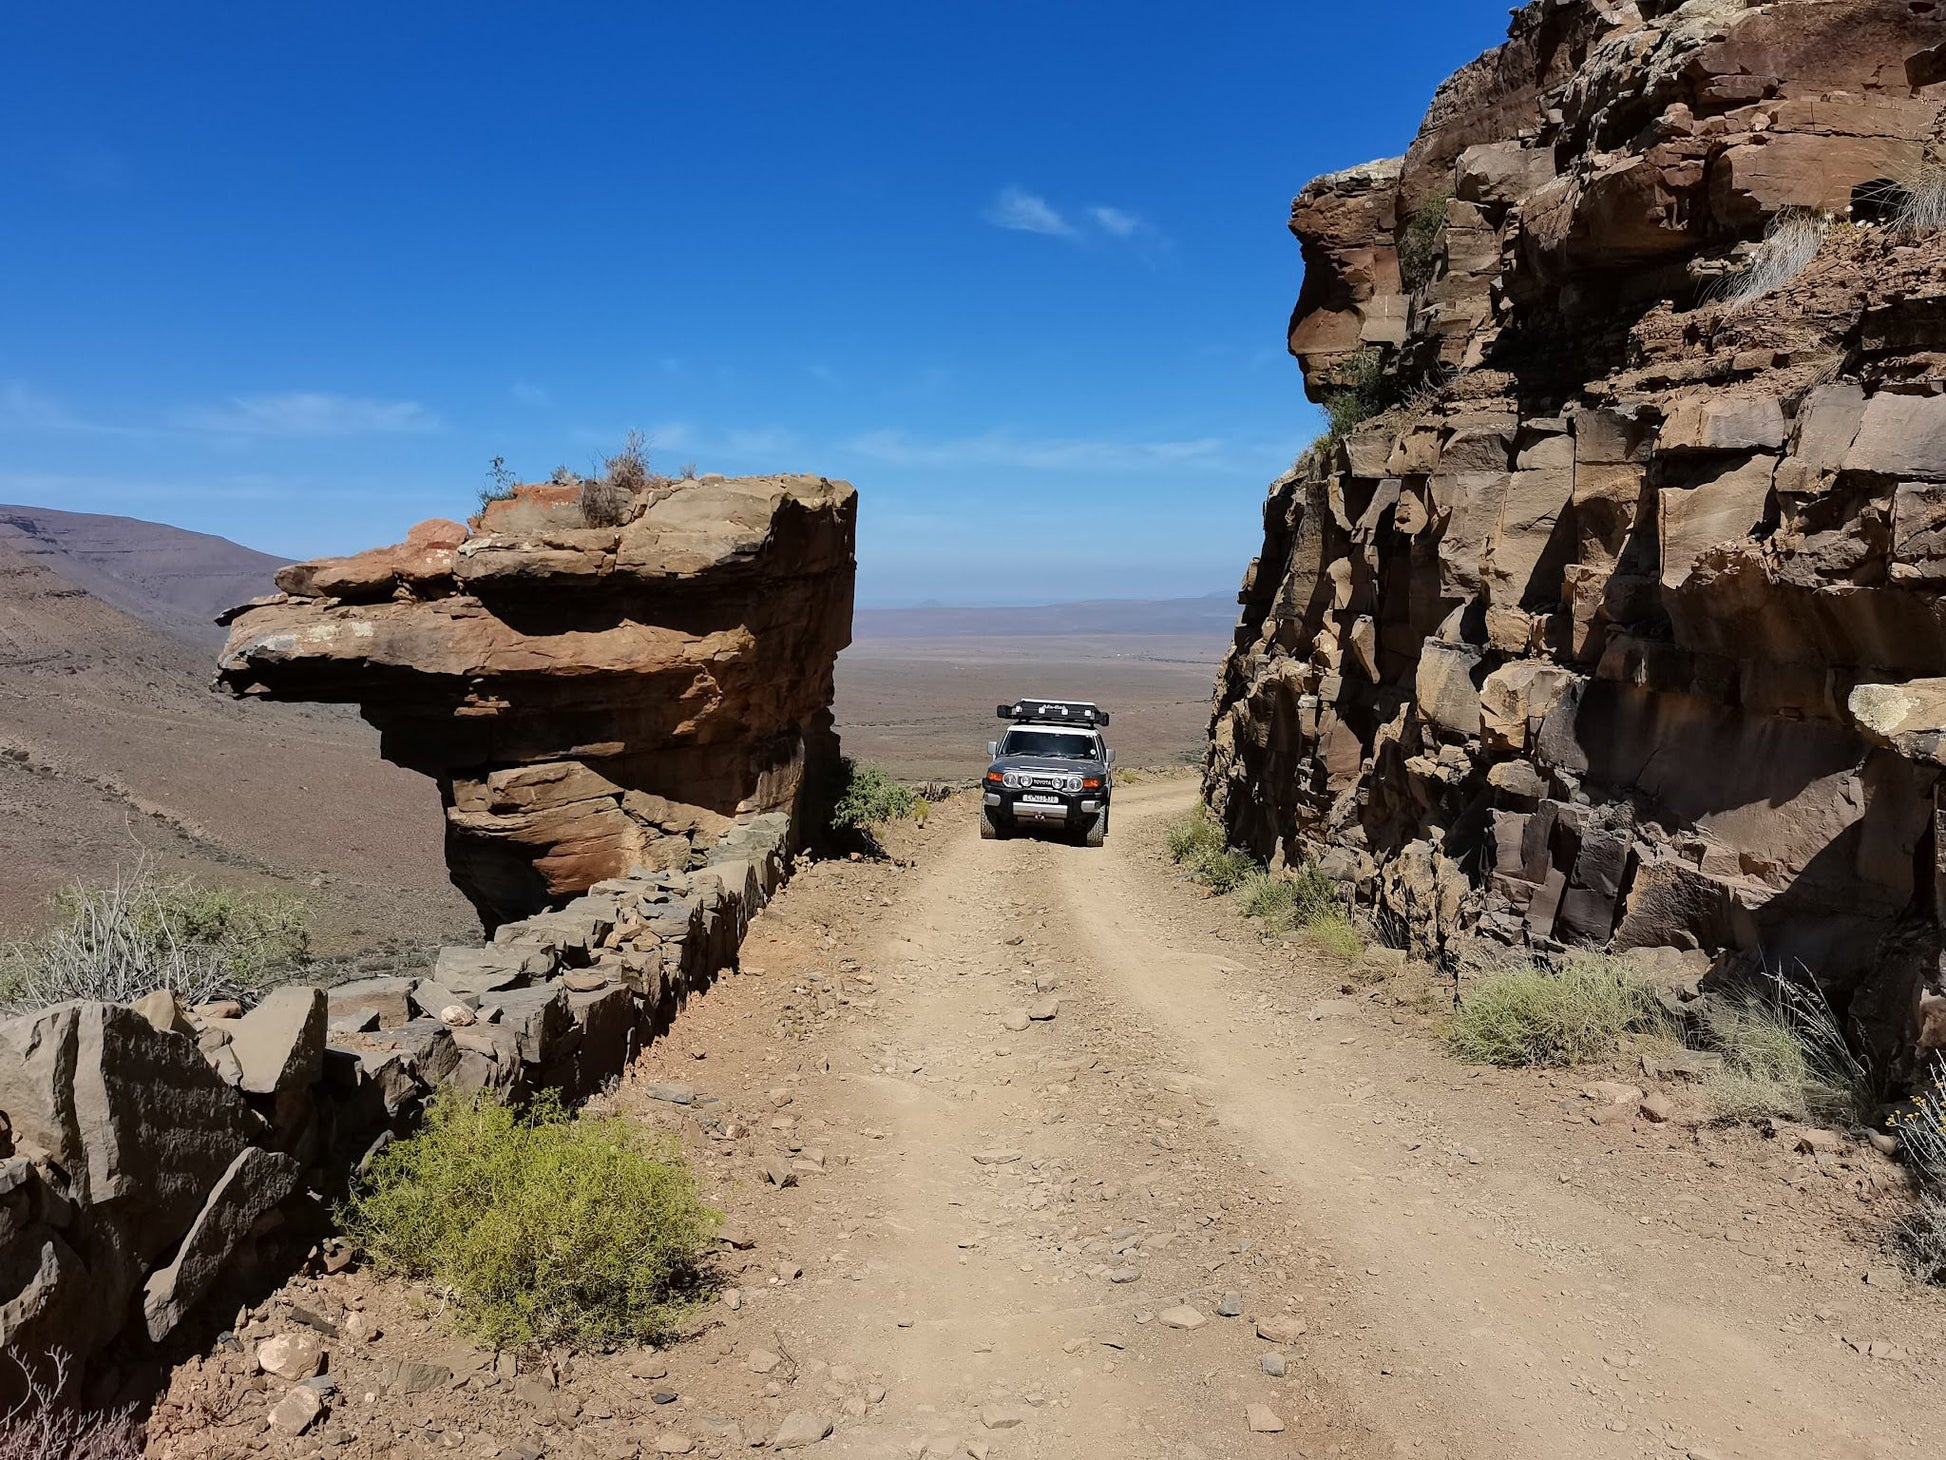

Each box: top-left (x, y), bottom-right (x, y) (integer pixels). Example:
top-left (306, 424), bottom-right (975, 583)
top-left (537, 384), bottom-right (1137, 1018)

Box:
top-left (979, 699), bottom-right (1115, 847)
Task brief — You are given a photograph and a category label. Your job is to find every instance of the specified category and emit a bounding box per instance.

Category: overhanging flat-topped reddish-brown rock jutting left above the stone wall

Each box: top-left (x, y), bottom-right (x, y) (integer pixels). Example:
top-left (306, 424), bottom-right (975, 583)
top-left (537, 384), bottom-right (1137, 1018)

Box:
top-left (220, 477), bottom-right (856, 931)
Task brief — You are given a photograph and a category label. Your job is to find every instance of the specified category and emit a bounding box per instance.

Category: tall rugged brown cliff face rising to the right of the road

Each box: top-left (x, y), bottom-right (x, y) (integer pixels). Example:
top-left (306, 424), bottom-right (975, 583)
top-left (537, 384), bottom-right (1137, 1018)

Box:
top-left (1207, 0), bottom-right (1946, 1071)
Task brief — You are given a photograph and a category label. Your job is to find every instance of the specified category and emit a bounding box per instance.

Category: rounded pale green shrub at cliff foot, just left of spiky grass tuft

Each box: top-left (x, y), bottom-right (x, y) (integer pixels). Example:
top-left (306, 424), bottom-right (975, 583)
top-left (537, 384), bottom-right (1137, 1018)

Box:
top-left (1446, 956), bottom-right (1668, 1067)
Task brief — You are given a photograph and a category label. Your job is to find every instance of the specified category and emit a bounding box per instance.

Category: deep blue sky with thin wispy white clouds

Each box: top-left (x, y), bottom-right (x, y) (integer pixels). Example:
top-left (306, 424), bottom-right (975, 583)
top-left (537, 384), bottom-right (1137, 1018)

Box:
top-left (0, 0), bottom-right (1506, 603)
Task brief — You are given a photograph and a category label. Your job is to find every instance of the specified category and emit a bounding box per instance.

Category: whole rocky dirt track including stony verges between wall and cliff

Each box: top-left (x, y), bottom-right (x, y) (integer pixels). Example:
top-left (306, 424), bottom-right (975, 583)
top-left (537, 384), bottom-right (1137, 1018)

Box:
top-left (152, 779), bottom-right (1946, 1460)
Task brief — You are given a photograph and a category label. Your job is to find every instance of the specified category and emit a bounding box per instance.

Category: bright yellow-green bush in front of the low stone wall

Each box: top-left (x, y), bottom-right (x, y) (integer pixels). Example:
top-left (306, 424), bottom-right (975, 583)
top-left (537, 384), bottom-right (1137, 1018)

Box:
top-left (339, 1088), bottom-right (720, 1349)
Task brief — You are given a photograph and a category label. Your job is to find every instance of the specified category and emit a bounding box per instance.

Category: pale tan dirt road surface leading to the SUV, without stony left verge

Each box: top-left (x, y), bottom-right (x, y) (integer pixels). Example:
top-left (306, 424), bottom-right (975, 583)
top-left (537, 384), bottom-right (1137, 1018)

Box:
top-left (642, 781), bottom-right (1942, 1460)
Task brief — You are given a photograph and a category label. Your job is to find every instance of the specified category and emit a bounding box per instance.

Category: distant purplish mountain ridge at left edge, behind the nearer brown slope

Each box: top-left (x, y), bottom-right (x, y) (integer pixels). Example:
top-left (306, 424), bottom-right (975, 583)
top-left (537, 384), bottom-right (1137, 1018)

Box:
top-left (0, 506), bottom-right (286, 650)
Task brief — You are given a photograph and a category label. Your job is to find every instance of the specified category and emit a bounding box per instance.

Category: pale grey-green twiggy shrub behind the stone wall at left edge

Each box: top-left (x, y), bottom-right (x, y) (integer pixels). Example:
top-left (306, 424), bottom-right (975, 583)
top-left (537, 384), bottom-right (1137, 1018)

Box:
top-left (0, 862), bottom-right (311, 1012)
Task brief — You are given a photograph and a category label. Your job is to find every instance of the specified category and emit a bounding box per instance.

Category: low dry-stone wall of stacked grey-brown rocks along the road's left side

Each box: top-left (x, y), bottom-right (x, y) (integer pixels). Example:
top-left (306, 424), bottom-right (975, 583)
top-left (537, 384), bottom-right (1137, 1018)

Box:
top-left (0, 825), bottom-right (790, 1402)
